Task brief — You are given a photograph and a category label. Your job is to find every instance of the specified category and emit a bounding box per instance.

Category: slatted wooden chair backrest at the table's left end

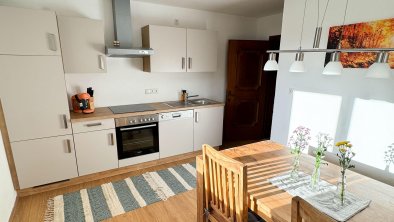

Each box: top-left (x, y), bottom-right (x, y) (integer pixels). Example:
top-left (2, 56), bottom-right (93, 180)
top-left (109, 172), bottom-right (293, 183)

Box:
top-left (203, 145), bottom-right (248, 222)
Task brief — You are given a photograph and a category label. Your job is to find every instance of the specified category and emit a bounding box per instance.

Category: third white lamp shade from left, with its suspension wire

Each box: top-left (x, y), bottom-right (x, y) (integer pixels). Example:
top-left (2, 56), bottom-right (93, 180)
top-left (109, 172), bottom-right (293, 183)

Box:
top-left (323, 0), bottom-right (349, 76)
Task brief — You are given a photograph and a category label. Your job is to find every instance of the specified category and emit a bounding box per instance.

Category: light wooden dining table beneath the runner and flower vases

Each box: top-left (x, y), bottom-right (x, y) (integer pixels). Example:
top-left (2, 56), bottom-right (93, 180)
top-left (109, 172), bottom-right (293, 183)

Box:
top-left (196, 141), bottom-right (394, 222)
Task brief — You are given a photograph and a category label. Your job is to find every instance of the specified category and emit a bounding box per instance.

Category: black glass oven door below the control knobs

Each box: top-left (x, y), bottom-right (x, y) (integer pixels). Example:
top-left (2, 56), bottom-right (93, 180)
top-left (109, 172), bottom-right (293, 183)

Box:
top-left (116, 123), bottom-right (159, 159)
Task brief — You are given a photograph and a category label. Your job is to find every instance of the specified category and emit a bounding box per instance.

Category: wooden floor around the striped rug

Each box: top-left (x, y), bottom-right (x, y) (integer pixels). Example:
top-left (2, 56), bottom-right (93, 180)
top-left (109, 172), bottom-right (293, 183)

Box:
top-left (10, 158), bottom-right (197, 222)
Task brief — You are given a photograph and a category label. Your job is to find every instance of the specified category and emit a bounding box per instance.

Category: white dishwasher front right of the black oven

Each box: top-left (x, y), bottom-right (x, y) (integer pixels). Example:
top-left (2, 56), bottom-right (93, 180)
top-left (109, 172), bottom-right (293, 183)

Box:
top-left (159, 110), bottom-right (194, 158)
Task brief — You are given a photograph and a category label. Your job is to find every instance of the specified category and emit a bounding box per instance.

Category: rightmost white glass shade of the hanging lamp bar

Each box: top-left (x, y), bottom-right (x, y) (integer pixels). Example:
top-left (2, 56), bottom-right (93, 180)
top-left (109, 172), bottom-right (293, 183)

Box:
top-left (365, 52), bottom-right (390, 79)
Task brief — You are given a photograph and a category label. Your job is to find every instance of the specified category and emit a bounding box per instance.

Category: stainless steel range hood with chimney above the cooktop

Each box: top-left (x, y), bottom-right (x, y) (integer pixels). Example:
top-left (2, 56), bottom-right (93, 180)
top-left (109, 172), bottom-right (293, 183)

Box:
top-left (105, 0), bottom-right (153, 58)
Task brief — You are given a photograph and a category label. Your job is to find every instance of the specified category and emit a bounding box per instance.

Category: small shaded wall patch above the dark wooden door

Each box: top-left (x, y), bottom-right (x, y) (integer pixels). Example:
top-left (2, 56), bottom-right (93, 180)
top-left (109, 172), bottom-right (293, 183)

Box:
top-left (257, 13), bottom-right (283, 40)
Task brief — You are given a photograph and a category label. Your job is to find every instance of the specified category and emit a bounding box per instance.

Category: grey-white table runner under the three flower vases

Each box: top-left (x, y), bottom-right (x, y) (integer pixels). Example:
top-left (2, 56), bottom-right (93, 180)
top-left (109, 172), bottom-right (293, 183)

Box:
top-left (268, 172), bottom-right (371, 221)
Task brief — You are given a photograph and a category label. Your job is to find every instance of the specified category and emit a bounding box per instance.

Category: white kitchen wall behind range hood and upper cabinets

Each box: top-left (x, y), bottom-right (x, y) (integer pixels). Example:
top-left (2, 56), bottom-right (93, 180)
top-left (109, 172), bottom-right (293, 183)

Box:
top-left (0, 0), bottom-right (257, 107)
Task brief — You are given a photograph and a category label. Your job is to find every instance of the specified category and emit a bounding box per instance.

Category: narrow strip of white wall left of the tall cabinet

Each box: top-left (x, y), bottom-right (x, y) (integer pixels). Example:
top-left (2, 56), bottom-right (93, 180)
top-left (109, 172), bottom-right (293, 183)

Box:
top-left (0, 132), bottom-right (16, 221)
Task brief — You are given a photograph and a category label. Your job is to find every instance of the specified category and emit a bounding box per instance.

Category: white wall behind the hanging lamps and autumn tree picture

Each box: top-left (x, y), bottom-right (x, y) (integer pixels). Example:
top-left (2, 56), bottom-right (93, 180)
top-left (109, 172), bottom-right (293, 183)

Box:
top-left (272, 0), bottom-right (394, 185)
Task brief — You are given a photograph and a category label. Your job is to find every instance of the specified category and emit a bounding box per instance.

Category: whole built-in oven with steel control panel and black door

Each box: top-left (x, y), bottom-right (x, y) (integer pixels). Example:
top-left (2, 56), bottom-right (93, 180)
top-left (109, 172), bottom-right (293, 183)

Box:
top-left (115, 114), bottom-right (159, 160)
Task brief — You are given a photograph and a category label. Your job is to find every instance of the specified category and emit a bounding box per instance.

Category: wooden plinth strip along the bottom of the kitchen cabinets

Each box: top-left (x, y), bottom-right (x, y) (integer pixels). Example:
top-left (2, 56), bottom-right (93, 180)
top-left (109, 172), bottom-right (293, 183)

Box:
top-left (17, 151), bottom-right (201, 197)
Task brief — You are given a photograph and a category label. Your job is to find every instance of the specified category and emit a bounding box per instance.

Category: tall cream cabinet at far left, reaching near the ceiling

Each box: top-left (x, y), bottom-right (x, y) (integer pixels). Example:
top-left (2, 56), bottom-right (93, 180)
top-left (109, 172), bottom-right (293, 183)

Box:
top-left (0, 6), bottom-right (78, 189)
